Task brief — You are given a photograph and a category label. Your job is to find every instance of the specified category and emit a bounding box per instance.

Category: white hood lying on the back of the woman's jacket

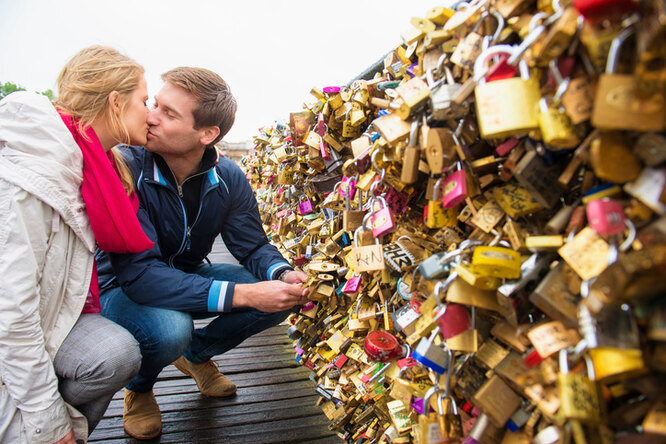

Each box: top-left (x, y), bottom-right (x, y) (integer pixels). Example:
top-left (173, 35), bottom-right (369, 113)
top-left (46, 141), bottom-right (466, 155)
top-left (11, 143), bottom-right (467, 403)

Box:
top-left (0, 91), bottom-right (95, 251)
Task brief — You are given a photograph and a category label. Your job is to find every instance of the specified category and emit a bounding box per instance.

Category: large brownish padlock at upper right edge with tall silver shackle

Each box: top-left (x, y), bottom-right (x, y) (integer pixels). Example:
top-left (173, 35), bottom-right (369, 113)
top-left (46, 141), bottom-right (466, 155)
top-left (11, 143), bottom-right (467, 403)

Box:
top-left (591, 27), bottom-right (666, 131)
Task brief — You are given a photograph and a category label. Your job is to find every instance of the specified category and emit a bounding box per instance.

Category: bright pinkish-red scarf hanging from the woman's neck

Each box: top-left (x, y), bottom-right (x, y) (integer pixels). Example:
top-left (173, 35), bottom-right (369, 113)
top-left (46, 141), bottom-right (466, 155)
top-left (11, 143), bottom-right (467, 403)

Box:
top-left (58, 110), bottom-right (154, 313)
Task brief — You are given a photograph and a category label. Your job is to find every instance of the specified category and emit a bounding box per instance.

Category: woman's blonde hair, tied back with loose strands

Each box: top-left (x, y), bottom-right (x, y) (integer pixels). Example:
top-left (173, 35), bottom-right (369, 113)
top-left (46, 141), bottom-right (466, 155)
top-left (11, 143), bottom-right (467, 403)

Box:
top-left (56, 45), bottom-right (144, 194)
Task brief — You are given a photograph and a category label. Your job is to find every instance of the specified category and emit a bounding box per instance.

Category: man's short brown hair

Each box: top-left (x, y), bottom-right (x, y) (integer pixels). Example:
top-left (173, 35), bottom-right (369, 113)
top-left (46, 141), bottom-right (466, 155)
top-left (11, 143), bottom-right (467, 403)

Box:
top-left (162, 66), bottom-right (237, 147)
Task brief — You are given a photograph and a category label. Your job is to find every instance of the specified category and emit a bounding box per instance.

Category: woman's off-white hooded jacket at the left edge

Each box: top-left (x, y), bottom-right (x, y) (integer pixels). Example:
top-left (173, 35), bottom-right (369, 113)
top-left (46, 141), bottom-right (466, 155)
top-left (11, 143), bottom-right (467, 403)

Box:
top-left (0, 92), bottom-right (95, 443)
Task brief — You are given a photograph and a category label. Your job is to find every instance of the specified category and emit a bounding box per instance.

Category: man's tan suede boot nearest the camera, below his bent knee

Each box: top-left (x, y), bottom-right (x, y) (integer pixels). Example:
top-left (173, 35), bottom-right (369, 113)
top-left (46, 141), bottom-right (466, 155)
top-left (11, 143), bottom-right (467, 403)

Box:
top-left (123, 389), bottom-right (162, 439)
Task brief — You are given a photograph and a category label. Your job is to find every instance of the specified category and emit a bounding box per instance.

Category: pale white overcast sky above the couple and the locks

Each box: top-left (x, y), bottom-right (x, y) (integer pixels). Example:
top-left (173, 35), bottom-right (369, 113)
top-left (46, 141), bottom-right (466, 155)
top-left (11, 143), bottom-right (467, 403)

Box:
top-left (0, 0), bottom-right (443, 142)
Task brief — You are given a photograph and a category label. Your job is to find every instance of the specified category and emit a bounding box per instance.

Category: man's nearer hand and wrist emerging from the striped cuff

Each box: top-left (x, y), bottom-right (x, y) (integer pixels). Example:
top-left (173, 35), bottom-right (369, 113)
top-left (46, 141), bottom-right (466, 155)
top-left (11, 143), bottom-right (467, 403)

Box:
top-left (232, 280), bottom-right (308, 313)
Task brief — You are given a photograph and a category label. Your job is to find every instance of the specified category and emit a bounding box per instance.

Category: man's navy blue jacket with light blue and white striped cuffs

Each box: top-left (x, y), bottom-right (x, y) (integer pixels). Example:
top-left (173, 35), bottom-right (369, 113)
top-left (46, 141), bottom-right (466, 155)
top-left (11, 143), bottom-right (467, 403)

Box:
top-left (96, 146), bottom-right (291, 312)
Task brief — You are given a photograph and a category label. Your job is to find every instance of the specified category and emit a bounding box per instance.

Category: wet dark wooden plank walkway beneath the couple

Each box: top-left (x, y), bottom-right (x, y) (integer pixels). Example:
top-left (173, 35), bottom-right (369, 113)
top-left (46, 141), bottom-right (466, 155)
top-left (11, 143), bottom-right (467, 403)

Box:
top-left (90, 242), bottom-right (342, 444)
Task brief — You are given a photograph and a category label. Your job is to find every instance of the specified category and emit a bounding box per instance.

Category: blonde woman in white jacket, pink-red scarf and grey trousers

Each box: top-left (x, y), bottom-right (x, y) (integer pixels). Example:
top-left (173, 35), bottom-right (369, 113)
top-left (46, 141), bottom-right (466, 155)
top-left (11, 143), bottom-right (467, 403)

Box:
top-left (0, 46), bottom-right (152, 443)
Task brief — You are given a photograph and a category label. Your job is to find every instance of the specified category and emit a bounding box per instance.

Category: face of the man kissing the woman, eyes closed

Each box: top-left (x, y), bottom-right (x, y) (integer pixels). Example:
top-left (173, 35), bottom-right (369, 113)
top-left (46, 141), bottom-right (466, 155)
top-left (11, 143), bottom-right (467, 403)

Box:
top-left (145, 83), bottom-right (204, 157)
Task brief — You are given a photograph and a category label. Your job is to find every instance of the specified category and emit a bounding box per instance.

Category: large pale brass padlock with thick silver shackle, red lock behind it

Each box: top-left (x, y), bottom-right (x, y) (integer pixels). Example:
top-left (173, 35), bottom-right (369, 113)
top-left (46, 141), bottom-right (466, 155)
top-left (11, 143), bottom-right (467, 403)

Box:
top-left (474, 45), bottom-right (540, 139)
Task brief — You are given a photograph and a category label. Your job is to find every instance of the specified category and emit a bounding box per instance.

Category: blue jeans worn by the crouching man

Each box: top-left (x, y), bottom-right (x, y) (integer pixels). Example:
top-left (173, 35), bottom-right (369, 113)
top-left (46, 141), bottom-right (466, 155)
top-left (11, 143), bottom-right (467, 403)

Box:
top-left (100, 263), bottom-right (289, 393)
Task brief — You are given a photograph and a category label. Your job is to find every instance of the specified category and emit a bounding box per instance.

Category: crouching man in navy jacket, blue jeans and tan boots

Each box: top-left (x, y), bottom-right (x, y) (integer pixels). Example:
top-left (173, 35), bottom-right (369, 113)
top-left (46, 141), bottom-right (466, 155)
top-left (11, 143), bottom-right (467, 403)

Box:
top-left (98, 67), bottom-right (307, 439)
